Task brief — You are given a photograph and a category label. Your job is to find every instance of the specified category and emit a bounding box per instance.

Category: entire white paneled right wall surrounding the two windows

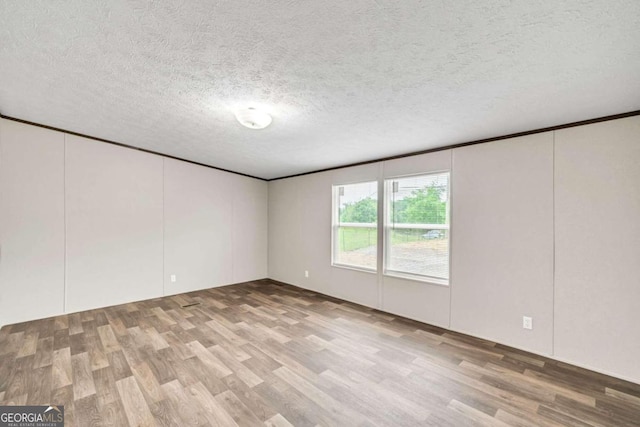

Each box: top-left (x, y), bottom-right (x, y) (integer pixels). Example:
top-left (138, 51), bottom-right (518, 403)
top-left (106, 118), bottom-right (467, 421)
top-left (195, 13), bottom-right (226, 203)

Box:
top-left (269, 117), bottom-right (640, 383)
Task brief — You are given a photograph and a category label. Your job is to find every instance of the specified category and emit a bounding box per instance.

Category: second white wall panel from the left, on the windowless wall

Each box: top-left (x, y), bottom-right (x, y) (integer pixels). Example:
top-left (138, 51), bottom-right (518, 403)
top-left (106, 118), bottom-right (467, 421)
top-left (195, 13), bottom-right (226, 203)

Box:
top-left (65, 135), bottom-right (163, 312)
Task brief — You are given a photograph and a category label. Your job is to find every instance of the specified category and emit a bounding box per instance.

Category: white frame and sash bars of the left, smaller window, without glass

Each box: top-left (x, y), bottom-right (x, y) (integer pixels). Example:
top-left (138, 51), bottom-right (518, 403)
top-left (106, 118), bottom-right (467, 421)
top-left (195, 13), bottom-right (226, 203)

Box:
top-left (331, 179), bottom-right (380, 274)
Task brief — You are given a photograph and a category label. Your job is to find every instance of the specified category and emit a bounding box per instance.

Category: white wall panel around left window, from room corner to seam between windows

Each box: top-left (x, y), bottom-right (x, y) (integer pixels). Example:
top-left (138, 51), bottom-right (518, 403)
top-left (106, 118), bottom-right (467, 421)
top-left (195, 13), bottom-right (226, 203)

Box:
top-left (269, 165), bottom-right (380, 307)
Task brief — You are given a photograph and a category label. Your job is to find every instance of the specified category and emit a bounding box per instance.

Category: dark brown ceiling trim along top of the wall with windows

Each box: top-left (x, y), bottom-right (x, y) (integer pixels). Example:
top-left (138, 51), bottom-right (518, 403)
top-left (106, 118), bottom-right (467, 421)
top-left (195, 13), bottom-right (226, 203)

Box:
top-left (267, 110), bottom-right (640, 182)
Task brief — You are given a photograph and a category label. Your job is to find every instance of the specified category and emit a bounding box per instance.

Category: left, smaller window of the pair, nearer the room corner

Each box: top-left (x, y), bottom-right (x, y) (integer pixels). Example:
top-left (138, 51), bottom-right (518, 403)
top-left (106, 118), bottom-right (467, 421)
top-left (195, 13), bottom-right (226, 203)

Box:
top-left (332, 181), bottom-right (378, 271)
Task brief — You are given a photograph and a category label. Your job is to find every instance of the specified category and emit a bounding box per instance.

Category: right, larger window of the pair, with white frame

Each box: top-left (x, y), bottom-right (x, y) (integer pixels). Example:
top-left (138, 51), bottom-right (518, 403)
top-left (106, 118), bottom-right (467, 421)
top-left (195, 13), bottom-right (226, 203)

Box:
top-left (384, 172), bottom-right (449, 284)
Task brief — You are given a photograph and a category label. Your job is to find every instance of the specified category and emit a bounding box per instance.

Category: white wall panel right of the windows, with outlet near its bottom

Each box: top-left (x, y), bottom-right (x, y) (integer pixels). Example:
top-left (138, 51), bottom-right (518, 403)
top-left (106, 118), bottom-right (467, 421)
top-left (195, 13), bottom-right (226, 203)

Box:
top-left (451, 132), bottom-right (553, 355)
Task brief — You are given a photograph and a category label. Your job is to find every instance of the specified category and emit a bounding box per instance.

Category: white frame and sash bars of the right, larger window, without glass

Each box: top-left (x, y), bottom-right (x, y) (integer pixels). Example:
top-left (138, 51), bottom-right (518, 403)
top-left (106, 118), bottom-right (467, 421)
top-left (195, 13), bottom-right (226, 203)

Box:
top-left (378, 169), bottom-right (451, 286)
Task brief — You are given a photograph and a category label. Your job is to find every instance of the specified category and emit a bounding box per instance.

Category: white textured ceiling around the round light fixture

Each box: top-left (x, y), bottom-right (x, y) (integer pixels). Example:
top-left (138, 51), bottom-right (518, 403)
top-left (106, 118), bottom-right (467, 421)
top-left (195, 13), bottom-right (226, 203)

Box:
top-left (0, 0), bottom-right (640, 178)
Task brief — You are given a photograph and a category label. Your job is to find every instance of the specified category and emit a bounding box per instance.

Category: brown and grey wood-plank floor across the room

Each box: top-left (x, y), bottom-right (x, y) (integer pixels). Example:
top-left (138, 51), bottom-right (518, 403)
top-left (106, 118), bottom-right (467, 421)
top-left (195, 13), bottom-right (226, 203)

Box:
top-left (0, 281), bottom-right (640, 426)
